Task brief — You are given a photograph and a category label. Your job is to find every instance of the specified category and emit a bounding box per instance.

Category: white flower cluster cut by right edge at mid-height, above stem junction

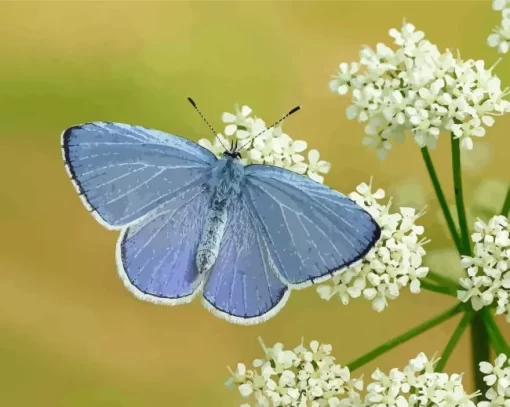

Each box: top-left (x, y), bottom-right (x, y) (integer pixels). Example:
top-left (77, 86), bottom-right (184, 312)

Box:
top-left (457, 215), bottom-right (510, 322)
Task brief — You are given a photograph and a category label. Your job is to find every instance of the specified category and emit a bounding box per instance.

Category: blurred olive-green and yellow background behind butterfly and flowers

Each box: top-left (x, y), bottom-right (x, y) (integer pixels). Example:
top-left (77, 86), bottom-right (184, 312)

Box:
top-left (0, 1), bottom-right (510, 407)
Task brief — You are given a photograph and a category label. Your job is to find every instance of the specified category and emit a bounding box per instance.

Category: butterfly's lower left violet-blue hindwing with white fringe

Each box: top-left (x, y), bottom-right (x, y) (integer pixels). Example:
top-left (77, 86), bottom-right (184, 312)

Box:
top-left (116, 181), bottom-right (211, 305)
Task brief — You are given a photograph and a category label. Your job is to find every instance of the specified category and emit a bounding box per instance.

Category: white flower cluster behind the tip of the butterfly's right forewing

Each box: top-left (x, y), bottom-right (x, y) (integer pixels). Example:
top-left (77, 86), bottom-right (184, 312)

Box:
top-left (317, 183), bottom-right (428, 311)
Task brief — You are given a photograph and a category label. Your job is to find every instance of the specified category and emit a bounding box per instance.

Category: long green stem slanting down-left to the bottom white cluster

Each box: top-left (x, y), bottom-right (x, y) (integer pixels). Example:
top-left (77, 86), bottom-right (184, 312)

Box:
top-left (347, 304), bottom-right (464, 372)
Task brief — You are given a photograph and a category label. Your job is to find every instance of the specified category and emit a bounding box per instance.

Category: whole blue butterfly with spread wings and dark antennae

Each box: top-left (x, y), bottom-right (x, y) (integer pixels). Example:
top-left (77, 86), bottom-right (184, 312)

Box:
top-left (62, 99), bottom-right (381, 325)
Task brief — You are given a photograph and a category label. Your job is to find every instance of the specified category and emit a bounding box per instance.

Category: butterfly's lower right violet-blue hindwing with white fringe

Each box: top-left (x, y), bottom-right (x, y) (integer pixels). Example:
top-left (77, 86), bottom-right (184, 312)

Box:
top-left (203, 194), bottom-right (290, 325)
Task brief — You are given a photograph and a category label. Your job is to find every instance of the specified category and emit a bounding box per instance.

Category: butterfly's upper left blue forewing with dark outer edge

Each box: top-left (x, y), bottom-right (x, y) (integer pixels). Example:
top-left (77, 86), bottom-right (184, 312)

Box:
top-left (62, 122), bottom-right (217, 229)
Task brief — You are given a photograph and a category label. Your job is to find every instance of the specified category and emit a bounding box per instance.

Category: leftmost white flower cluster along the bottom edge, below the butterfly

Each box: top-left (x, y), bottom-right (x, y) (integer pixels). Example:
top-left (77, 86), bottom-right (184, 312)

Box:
top-left (227, 338), bottom-right (363, 407)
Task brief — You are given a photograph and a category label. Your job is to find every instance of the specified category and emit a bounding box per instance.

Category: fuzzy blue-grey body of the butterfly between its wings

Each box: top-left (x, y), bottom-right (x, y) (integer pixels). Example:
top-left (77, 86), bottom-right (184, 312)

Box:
top-left (196, 155), bottom-right (244, 274)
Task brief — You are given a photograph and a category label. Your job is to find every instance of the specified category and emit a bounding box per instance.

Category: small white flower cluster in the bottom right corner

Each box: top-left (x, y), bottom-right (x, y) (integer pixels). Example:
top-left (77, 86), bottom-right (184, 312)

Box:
top-left (478, 353), bottom-right (510, 407)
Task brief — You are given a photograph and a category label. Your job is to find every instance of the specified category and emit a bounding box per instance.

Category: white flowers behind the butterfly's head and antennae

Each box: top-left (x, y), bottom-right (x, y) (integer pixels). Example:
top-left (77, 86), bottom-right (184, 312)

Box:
top-left (198, 105), bottom-right (331, 183)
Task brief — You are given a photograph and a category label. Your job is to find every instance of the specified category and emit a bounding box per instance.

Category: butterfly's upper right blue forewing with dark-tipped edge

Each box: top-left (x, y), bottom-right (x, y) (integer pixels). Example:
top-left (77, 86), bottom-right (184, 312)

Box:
top-left (244, 165), bottom-right (381, 288)
